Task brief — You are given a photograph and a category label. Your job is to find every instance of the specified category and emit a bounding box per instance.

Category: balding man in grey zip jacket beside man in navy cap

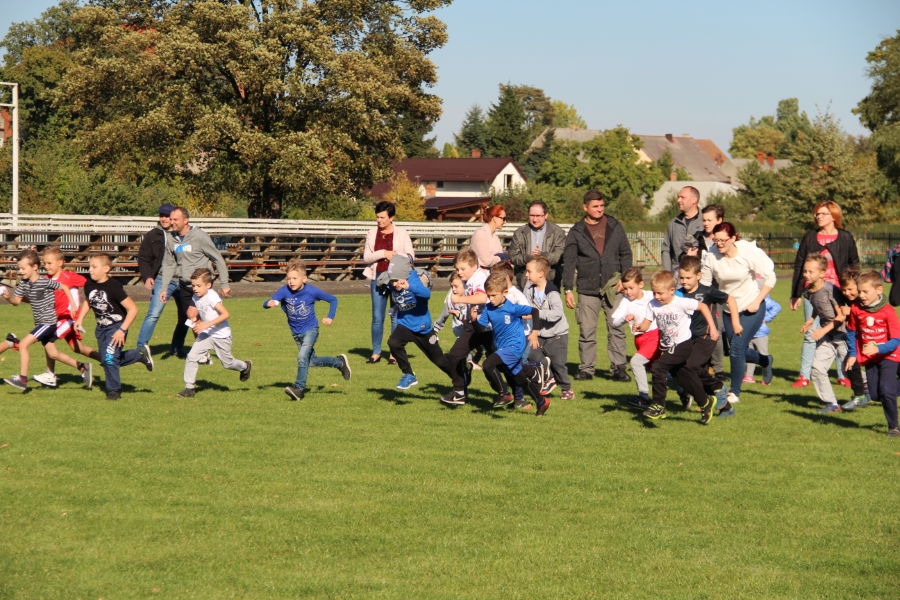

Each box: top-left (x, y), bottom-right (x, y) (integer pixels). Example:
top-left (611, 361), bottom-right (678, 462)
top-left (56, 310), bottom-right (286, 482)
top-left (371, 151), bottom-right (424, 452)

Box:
top-left (159, 206), bottom-right (231, 358)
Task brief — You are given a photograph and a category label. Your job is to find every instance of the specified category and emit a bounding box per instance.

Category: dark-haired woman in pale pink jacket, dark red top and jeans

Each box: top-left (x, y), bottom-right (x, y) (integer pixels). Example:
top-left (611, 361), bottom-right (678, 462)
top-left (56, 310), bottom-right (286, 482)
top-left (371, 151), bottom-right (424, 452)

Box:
top-left (363, 202), bottom-right (415, 364)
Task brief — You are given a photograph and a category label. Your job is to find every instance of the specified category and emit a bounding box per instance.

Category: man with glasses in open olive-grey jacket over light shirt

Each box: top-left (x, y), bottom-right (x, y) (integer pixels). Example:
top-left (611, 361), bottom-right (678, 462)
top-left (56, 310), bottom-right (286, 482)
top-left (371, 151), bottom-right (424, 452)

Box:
top-left (509, 200), bottom-right (566, 290)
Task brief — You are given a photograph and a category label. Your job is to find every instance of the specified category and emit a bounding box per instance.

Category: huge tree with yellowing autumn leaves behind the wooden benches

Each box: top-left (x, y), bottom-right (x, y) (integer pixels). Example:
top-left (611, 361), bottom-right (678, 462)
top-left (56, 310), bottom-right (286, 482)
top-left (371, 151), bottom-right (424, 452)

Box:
top-left (56, 0), bottom-right (451, 218)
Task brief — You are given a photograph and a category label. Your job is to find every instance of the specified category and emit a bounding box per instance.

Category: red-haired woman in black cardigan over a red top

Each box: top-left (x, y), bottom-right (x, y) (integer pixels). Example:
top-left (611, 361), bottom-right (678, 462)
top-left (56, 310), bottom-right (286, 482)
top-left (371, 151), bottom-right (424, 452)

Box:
top-left (791, 201), bottom-right (859, 387)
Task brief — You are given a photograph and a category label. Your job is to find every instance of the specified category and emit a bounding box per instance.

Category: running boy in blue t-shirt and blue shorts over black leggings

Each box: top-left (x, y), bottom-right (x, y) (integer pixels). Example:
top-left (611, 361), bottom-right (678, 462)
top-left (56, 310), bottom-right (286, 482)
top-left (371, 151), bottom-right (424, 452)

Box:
top-left (478, 273), bottom-right (550, 417)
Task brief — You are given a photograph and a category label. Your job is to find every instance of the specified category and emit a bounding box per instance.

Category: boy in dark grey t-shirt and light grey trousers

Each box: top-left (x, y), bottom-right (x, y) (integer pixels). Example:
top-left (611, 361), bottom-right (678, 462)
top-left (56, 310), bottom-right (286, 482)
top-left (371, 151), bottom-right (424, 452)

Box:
top-left (800, 253), bottom-right (847, 413)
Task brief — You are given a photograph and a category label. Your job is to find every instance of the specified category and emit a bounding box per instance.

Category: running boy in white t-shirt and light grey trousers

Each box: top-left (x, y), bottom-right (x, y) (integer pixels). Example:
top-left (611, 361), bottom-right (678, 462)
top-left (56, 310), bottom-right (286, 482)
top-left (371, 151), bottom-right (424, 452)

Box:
top-left (176, 269), bottom-right (253, 398)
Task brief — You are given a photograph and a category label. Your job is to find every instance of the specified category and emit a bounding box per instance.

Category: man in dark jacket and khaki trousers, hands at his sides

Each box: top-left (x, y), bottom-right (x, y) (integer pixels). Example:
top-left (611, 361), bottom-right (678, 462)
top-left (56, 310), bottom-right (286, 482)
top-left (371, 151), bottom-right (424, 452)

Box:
top-left (563, 190), bottom-right (632, 381)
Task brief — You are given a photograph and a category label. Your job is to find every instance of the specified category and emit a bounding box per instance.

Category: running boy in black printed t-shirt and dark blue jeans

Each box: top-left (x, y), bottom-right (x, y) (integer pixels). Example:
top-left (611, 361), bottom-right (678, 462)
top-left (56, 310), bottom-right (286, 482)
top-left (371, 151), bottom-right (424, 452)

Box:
top-left (73, 253), bottom-right (153, 400)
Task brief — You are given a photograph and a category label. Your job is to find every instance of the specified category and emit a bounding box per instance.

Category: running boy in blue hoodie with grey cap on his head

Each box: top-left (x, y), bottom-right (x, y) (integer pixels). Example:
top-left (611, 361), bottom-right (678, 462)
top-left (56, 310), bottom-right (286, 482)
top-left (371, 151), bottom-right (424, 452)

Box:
top-left (379, 254), bottom-right (450, 390)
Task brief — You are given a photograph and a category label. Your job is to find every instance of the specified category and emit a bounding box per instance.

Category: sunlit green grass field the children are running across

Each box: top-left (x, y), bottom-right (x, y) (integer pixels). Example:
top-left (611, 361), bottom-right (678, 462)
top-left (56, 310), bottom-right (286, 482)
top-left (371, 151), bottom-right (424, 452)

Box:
top-left (0, 282), bottom-right (900, 599)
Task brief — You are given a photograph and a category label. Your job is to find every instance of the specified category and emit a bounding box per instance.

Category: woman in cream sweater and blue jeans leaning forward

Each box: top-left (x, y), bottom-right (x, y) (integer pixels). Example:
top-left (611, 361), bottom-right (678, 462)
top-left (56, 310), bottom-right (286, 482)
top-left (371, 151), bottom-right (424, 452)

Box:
top-left (700, 221), bottom-right (775, 403)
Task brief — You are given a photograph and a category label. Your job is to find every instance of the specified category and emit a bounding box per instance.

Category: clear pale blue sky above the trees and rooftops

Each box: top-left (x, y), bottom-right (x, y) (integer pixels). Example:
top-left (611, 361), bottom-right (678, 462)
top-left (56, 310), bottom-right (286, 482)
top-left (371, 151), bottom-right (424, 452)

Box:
top-left (0, 0), bottom-right (900, 151)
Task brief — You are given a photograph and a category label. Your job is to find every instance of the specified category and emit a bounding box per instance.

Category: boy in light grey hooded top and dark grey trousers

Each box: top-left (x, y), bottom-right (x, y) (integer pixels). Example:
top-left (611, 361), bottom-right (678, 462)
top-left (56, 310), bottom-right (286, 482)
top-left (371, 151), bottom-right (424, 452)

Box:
top-left (525, 256), bottom-right (575, 400)
